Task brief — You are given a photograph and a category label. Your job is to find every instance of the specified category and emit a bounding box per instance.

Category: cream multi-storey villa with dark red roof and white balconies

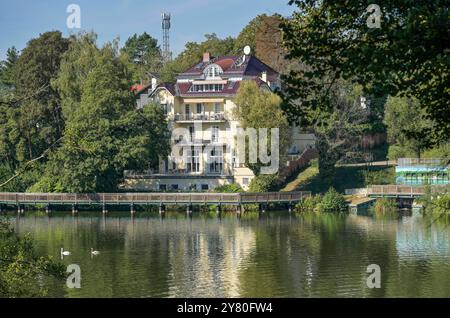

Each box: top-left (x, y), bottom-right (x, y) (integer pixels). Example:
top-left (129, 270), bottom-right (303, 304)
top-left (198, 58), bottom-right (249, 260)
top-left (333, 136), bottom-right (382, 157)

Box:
top-left (121, 53), bottom-right (315, 191)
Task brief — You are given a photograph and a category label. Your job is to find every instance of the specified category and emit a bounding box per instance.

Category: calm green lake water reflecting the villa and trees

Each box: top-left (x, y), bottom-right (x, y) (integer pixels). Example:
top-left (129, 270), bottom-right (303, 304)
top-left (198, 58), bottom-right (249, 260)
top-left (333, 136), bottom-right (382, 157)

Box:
top-left (6, 212), bottom-right (450, 297)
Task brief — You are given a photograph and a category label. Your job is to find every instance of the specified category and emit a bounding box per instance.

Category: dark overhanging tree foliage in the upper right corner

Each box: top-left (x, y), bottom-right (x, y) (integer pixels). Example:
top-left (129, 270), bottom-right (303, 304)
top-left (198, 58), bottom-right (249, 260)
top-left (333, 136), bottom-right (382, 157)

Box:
top-left (282, 0), bottom-right (450, 141)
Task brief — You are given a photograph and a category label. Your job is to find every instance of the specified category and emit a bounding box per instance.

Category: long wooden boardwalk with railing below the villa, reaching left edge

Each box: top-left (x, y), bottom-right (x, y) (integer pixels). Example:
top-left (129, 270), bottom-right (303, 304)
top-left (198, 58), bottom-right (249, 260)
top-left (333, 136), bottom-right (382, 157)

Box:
top-left (0, 191), bottom-right (311, 210)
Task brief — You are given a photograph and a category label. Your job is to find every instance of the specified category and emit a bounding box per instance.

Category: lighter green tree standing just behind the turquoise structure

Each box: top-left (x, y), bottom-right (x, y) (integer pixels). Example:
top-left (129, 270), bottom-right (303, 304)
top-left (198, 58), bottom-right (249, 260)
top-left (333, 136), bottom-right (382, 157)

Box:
top-left (384, 96), bottom-right (436, 159)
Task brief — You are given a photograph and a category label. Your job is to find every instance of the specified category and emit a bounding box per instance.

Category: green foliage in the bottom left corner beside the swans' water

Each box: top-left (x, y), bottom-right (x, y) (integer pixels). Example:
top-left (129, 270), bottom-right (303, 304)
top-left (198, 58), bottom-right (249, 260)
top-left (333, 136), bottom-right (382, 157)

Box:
top-left (0, 220), bottom-right (66, 297)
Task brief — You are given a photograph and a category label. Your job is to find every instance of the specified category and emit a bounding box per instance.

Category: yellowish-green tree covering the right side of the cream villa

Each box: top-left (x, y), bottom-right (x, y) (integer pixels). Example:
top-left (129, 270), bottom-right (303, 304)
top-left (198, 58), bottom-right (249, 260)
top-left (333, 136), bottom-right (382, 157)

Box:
top-left (234, 81), bottom-right (290, 175)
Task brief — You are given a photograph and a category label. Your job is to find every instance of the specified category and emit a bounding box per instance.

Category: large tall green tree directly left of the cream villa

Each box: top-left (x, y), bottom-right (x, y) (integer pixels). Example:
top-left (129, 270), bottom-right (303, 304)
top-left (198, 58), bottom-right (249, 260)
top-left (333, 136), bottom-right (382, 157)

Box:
top-left (33, 43), bottom-right (169, 192)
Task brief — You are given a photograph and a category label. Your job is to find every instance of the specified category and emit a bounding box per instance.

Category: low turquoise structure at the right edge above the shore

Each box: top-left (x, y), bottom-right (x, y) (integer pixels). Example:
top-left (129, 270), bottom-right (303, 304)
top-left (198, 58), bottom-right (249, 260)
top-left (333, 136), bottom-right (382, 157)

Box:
top-left (395, 158), bottom-right (450, 185)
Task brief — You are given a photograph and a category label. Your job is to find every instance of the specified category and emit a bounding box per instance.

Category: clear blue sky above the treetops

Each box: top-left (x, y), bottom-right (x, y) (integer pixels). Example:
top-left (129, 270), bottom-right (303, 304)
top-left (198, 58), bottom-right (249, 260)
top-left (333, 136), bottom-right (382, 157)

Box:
top-left (0, 0), bottom-right (295, 59)
